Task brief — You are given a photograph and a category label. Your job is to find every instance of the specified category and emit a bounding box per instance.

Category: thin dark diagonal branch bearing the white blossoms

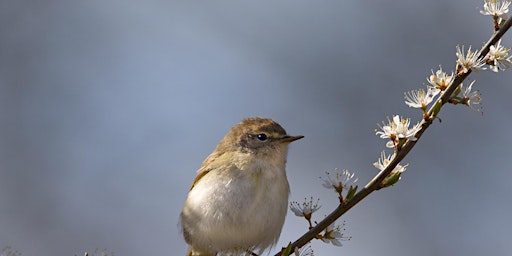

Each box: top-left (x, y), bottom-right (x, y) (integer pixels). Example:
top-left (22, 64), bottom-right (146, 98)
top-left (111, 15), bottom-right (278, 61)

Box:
top-left (275, 19), bottom-right (512, 256)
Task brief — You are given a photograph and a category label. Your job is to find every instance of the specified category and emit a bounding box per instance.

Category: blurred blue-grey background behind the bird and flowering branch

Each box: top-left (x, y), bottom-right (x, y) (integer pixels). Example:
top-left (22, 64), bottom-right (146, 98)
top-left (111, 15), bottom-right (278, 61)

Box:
top-left (0, 0), bottom-right (512, 256)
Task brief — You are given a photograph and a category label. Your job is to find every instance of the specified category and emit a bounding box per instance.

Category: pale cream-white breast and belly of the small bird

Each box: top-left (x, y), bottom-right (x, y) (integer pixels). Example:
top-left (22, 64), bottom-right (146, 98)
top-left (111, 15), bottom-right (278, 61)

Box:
top-left (182, 152), bottom-right (289, 251)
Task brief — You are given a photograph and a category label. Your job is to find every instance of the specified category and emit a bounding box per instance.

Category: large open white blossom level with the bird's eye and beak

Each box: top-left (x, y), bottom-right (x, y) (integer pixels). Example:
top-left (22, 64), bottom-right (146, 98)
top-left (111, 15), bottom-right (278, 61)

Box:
top-left (375, 115), bottom-right (421, 148)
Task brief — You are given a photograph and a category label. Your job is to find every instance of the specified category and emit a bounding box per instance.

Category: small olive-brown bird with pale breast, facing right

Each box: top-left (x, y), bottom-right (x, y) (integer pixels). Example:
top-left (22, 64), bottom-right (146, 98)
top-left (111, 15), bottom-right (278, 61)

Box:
top-left (180, 117), bottom-right (304, 256)
